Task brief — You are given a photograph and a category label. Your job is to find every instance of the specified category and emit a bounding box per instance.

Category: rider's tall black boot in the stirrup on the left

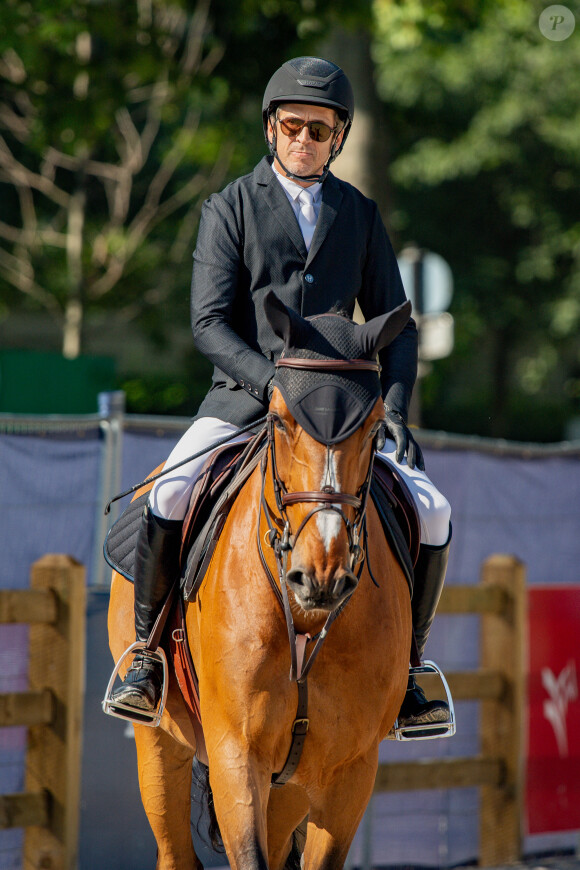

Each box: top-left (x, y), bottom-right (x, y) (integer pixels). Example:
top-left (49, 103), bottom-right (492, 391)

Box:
top-left (112, 507), bottom-right (183, 712)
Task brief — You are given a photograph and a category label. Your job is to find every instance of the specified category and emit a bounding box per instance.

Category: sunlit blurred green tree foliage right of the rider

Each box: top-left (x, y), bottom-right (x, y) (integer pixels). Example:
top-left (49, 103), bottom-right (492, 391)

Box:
top-left (374, 0), bottom-right (580, 440)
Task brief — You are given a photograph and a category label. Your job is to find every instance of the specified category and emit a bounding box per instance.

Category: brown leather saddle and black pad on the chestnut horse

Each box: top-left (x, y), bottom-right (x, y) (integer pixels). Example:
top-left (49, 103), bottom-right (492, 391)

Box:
top-left (104, 431), bottom-right (420, 744)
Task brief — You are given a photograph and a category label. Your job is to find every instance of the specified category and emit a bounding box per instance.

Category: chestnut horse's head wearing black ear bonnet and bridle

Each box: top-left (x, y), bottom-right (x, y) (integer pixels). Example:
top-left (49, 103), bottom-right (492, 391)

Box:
top-left (264, 292), bottom-right (411, 616)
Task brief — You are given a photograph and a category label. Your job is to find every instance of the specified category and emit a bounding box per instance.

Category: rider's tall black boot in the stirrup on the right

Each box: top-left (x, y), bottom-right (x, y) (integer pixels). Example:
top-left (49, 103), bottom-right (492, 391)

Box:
top-left (399, 529), bottom-right (451, 727)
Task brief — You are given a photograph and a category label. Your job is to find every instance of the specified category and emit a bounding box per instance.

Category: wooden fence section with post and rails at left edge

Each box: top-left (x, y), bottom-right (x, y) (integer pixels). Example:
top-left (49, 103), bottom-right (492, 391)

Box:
top-left (0, 555), bottom-right (86, 870)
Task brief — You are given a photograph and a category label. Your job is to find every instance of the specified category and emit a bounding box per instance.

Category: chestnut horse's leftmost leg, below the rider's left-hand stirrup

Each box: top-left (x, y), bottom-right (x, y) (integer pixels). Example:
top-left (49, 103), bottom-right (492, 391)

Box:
top-left (134, 725), bottom-right (203, 870)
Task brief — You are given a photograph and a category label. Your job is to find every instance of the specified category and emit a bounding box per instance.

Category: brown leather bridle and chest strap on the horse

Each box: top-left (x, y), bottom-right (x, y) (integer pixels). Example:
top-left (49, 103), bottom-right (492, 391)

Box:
top-left (264, 357), bottom-right (381, 788)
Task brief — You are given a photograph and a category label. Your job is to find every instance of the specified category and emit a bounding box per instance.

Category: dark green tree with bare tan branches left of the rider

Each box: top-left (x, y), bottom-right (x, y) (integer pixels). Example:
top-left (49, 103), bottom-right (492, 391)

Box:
top-left (0, 0), bottom-right (367, 412)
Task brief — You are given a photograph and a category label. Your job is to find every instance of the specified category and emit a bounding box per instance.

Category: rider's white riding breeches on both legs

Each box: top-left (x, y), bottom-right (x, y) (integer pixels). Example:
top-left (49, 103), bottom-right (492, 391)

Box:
top-left (149, 417), bottom-right (451, 547)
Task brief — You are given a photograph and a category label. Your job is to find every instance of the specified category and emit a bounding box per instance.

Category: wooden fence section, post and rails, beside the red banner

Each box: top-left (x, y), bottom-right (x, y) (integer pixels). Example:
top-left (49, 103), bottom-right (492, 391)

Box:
top-left (375, 555), bottom-right (526, 866)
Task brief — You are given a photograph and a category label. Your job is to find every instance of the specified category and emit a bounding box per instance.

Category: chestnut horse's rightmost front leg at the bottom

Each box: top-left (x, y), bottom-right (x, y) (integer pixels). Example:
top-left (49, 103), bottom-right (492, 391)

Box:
top-left (304, 747), bottom-right (378, 870)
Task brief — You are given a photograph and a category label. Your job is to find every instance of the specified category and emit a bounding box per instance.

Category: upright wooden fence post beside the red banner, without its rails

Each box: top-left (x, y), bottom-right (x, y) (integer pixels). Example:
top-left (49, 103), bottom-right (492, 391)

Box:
top-left (479, 555), bottom-right (526, 867)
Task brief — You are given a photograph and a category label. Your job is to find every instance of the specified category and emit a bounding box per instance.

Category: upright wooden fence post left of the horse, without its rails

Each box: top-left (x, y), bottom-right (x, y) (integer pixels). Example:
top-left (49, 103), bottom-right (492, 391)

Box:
top-left (23, 555), bottom-right (86, 870)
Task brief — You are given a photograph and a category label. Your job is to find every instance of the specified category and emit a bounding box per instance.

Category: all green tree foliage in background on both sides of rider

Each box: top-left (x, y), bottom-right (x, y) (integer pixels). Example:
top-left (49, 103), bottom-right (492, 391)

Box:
top-left (0, 0), bottom-right (580, 440)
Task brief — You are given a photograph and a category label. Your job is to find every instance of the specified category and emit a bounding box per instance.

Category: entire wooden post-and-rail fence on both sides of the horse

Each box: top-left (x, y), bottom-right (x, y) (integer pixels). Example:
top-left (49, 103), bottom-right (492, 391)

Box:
top-left (0, 555), bottom-right (526, 870)
